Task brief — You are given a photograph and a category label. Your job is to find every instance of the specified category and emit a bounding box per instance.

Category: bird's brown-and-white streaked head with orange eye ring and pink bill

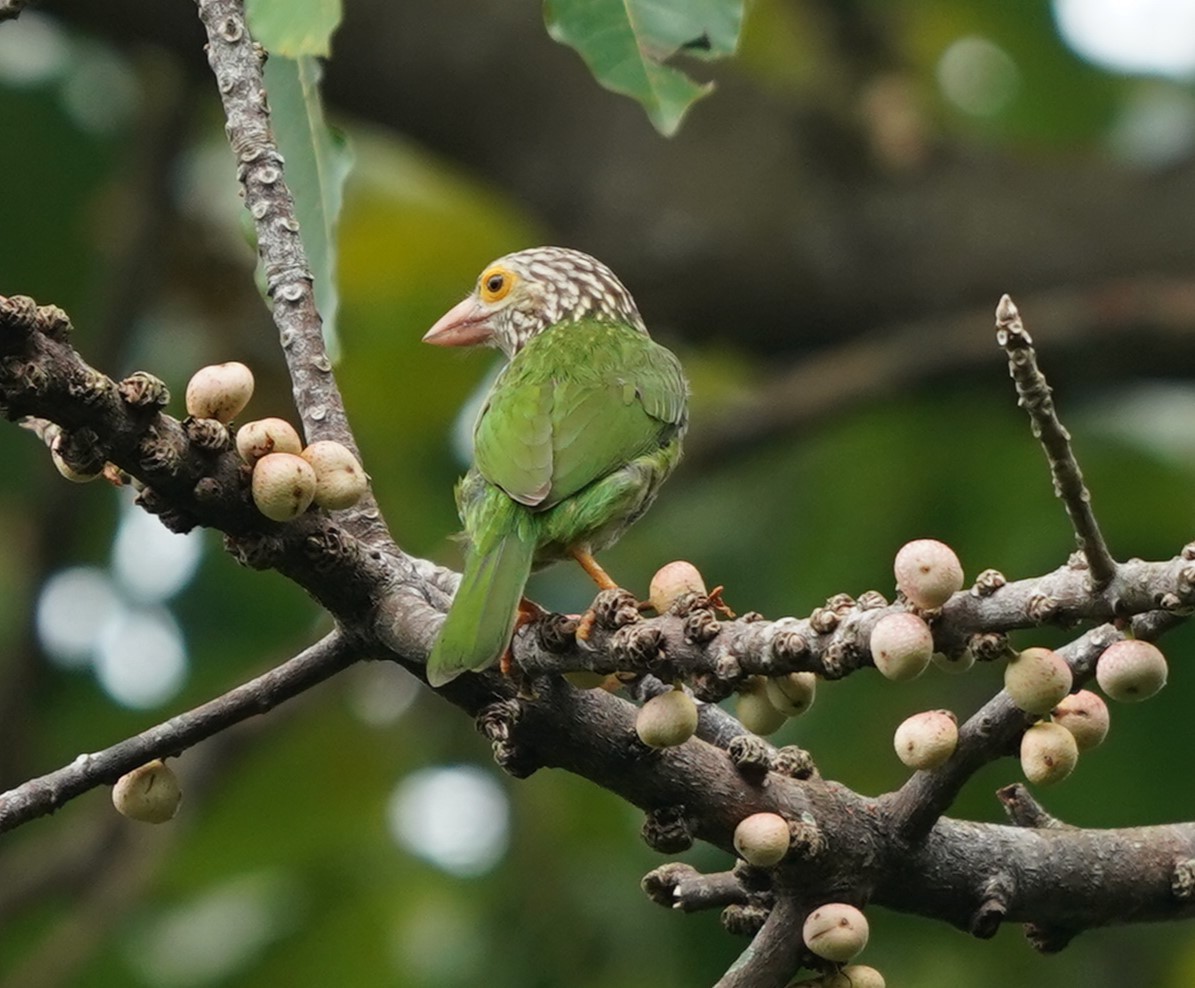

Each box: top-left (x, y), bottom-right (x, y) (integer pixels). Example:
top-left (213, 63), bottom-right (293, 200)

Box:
top-left (423, 247), bottom-right (646, 357)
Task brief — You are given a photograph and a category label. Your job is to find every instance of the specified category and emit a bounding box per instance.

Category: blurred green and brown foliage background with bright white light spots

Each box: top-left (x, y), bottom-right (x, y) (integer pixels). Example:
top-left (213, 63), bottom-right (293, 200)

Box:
top-left (0, 0), bottom-right (1195, 988)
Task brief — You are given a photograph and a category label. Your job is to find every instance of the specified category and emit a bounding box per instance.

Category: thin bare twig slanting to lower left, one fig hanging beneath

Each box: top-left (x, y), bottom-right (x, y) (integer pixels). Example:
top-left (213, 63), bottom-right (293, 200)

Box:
top-left (0, 631), bottom-right (362, 833)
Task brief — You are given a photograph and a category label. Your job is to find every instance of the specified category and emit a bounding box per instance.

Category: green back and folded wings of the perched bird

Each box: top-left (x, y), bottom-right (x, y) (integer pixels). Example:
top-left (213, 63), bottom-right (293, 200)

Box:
top-left (474, 326), bottom-right (686, 508)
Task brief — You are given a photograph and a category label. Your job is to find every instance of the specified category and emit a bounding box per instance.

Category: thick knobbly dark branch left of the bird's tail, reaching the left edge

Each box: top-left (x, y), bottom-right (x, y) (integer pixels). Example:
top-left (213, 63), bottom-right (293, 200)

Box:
top-left (0, 296), bottom-right (420, 626)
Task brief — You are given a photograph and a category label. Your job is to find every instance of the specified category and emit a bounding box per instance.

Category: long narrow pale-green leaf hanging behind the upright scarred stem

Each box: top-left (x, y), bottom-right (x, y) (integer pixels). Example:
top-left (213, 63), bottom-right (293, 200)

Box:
top-left (265, 55), bottom-right (353, 360)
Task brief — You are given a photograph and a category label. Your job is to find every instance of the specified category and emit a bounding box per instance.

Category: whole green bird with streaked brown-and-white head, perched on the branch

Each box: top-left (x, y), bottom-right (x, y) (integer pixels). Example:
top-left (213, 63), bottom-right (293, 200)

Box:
top-left (423, 247), bottom-right (688, 686)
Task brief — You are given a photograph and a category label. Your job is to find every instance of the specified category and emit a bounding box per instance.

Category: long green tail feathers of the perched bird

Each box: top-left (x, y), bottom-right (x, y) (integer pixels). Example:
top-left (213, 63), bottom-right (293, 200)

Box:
top-left (428, 526), bottom-right (535, 686)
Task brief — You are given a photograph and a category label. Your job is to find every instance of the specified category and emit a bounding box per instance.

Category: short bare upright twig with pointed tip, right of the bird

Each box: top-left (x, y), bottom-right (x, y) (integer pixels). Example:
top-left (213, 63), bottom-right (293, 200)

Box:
top-left (995, 295), bottom-right (1116, 590)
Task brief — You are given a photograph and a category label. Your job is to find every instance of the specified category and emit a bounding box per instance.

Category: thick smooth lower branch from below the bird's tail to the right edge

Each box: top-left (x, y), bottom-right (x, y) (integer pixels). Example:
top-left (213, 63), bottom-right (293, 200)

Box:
top-left (513, 683), bottom-right (1195, 950)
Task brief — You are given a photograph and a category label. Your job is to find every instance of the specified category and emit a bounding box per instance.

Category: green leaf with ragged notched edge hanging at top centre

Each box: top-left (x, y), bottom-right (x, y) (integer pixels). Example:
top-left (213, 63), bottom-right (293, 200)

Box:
top-left (544, 0), bottom-right (743, 136)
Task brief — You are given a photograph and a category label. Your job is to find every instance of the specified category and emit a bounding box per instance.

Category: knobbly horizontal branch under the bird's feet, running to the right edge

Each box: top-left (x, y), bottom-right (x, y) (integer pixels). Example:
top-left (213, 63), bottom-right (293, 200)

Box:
top-left (514, 548), bottom-right (1195, 699)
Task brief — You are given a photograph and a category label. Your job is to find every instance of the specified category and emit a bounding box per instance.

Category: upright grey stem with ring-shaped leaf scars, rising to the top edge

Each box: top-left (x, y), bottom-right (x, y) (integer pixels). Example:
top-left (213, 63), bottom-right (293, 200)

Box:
top-left (197, 0), bottom-right (390, 541)
